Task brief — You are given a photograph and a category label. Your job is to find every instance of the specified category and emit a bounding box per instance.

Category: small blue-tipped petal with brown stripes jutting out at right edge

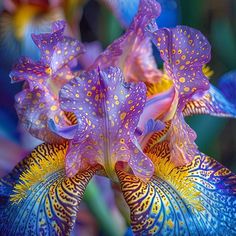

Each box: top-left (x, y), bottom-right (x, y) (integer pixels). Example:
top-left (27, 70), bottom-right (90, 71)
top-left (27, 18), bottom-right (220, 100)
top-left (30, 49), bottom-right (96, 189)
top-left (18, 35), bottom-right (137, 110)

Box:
top-left (183, 85), bottom-right (236, 117)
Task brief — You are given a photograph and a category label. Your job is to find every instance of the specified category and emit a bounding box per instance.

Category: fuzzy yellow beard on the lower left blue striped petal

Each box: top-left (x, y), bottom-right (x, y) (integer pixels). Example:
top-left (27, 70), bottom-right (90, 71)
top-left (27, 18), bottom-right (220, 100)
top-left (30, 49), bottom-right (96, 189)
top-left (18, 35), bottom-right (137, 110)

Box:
top-left (10, 143), bottom-right (67, 203)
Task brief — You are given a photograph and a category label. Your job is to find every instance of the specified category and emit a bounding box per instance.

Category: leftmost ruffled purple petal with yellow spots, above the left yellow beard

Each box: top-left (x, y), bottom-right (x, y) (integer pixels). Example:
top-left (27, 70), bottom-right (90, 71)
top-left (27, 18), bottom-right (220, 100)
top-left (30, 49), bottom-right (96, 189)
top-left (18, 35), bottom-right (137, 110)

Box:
top-left (10, 21), bottom-right (83, 142)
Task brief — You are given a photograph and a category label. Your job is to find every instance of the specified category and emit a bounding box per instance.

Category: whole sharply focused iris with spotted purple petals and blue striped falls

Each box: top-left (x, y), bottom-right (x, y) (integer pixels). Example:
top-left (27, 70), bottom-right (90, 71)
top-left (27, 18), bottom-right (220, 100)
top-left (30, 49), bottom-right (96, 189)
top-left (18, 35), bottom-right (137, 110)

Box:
top-left (0, 0), bottom-right (236, 235)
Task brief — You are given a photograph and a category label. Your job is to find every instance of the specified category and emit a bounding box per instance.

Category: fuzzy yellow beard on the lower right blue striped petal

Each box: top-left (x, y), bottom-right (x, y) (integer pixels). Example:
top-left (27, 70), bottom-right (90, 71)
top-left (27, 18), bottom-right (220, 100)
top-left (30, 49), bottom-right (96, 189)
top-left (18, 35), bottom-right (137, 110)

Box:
top-left (147, 154), bottom-right (204, 211)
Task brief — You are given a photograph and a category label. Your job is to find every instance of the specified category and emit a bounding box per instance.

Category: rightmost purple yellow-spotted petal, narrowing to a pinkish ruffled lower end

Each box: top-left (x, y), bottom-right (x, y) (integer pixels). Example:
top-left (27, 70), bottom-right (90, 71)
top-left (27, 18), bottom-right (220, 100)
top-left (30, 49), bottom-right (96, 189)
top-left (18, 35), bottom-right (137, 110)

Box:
top-left (149, 22), bottom-right (211, 166)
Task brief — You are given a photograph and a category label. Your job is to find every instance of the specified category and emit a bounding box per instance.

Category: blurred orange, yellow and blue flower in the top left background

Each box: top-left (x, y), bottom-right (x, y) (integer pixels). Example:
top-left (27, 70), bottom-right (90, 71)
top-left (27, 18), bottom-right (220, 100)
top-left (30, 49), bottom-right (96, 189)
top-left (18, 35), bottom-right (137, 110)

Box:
top-left (0, 0), bottom-right (86, 67)
